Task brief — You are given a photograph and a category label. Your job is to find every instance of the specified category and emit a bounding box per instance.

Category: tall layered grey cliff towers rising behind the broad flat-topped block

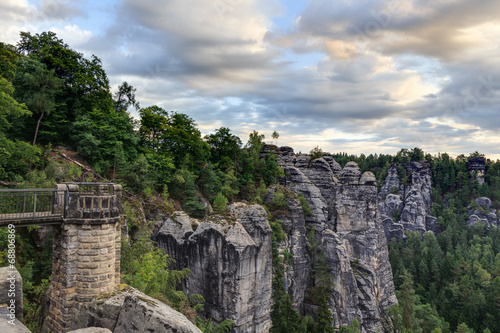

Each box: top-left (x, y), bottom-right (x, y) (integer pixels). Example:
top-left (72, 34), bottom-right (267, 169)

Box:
top-left (278, 147), bottom-right (397, 332)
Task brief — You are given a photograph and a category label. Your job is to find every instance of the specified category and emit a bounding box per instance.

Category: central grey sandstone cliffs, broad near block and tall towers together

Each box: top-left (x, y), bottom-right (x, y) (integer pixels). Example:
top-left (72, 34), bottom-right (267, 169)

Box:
top-left (153, 147), bottom-right (396, 333)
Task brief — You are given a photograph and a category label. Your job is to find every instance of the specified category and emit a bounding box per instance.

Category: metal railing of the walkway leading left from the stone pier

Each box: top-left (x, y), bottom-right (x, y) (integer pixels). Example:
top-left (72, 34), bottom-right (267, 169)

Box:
top-left (0, 188), bottom-right (66, 220)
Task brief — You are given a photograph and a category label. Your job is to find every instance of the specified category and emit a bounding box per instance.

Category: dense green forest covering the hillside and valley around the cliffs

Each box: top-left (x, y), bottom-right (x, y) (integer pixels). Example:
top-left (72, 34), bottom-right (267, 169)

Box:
top-left (0, 32), bottom-right (500, 333)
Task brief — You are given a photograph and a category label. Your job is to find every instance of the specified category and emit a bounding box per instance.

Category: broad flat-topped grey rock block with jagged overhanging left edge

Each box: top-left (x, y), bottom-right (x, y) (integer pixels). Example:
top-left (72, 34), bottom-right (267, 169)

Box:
top-left (153, 203), bottom-right (272, 333)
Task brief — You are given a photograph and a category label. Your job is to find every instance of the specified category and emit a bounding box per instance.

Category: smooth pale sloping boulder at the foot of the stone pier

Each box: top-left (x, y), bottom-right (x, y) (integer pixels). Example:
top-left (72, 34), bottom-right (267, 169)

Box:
top-left (75, 285), bottom-right (201, 333)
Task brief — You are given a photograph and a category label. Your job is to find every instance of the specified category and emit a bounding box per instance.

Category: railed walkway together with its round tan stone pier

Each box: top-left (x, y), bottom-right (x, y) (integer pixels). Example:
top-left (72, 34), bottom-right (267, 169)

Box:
top-left (0, 183), bottom-right (124, 333)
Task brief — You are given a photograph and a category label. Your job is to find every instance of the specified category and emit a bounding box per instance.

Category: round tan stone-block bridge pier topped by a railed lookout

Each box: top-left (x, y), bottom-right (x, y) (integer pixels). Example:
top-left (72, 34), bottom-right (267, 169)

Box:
top-left (43, 183), bottom-right (124, 333)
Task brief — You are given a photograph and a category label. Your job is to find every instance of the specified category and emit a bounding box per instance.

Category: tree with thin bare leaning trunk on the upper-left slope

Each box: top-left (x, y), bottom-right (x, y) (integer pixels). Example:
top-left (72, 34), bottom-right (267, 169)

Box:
top-left (15, 57), bottom-right (62, 146)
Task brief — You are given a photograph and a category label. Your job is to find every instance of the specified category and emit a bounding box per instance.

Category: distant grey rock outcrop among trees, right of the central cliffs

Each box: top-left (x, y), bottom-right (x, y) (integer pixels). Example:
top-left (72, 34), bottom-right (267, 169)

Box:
top-left (378, 161), bottom-right (439, 240)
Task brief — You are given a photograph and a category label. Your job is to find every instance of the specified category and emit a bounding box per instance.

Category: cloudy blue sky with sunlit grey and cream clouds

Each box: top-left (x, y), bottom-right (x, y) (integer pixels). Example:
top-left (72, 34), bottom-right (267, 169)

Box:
top-left (0, 0), bottom-right (500, 160)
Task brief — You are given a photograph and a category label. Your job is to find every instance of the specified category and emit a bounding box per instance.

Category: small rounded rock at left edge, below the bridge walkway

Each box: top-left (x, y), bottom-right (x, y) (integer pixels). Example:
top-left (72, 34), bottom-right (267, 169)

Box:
top-left (0, 267), bottom-right (23, 321)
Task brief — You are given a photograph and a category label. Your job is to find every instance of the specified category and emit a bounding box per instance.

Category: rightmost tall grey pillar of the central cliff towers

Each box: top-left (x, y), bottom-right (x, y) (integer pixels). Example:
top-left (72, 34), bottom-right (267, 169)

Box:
top-left (323, 176), bottom-right (397, 332)
